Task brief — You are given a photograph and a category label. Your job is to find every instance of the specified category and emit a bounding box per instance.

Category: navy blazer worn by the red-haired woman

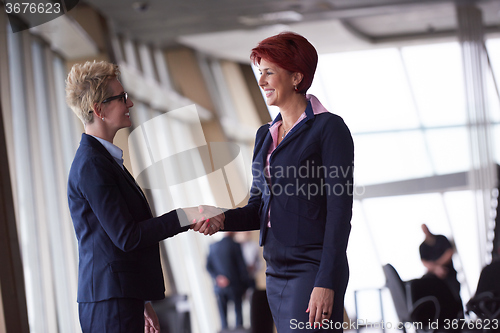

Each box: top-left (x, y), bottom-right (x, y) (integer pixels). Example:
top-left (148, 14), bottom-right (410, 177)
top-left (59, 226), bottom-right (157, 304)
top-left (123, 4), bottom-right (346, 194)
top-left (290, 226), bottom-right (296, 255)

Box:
top-left (225, 102), bottom-right (354, 290)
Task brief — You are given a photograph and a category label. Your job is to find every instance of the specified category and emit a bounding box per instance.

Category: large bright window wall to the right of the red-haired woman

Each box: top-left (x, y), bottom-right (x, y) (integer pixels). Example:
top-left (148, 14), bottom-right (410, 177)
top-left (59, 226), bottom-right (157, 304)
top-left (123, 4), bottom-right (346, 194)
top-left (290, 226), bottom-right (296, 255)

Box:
top-left (309, 39), bottom-right (500, 320)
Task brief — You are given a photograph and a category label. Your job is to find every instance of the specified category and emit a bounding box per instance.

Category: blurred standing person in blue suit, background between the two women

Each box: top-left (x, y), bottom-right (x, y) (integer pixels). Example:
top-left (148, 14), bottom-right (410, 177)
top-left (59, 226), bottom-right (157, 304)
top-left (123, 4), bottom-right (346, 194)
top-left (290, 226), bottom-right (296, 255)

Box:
top-left (207, 232), bottom-right (250, 329)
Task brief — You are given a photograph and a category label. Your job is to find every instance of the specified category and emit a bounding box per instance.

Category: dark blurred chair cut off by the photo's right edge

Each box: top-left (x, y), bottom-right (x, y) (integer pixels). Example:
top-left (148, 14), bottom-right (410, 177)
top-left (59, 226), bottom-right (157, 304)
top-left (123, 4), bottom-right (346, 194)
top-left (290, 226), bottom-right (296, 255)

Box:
top-left (466, 261), bottom-right (500, 321)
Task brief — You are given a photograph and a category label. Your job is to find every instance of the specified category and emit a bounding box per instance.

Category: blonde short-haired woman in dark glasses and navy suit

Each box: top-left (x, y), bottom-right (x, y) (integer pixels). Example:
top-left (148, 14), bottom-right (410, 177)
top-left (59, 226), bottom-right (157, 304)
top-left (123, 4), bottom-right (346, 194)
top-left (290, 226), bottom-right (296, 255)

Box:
top-left (66, 61), bottom-right (222, 333)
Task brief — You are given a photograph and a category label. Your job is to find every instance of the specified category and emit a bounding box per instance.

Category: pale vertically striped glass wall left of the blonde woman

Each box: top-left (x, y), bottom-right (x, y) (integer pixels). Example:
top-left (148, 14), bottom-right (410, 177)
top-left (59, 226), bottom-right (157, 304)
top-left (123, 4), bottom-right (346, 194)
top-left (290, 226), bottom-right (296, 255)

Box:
top-left (5, 28), bottom-right (80, 332)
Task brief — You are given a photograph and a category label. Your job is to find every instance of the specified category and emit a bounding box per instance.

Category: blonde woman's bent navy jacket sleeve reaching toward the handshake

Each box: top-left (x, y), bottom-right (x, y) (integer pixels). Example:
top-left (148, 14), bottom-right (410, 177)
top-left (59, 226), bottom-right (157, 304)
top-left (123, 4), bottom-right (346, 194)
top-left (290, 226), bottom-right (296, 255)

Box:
top-left (79, 156), bottom-right (189, 252)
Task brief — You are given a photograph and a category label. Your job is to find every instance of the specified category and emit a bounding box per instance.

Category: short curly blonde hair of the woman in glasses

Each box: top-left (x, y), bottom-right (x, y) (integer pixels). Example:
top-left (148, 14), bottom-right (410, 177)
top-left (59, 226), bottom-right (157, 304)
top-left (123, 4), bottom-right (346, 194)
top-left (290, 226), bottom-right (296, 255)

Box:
top-left (66, 61), bottom-right (120, 125)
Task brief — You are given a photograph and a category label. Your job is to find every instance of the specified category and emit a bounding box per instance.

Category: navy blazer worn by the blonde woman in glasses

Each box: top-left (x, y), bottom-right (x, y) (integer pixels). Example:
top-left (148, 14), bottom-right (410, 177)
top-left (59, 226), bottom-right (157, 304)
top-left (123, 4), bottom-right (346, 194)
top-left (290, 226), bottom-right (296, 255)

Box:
top-left (68, 133), bottom-right (189, 302)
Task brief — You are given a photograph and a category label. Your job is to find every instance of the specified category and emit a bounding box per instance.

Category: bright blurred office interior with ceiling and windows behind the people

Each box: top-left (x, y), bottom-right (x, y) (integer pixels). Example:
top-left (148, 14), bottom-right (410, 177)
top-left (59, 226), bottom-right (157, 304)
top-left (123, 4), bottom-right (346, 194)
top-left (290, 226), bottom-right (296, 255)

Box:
top-left (0, 0), bottom-right (500, 333)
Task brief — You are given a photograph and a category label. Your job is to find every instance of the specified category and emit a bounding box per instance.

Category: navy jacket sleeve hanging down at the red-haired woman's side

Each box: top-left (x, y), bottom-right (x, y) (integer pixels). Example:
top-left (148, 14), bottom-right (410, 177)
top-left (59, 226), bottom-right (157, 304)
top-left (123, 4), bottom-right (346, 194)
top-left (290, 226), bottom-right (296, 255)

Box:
top-left (315, 116), bottom-right (354, 290)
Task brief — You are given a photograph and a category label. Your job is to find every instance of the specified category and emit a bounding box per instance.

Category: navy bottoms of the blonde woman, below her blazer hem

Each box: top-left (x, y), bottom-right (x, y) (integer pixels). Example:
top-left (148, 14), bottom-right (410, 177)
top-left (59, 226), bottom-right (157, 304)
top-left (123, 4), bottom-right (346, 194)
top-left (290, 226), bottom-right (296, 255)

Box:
top-left (78, 298), bottom-right (144, 333)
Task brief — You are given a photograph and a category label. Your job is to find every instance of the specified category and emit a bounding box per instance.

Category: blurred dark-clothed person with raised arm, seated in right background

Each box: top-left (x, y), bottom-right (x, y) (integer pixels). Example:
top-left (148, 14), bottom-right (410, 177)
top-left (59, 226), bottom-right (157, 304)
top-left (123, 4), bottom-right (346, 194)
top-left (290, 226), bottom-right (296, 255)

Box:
top-left (420, 224), bottom-right (460, 299)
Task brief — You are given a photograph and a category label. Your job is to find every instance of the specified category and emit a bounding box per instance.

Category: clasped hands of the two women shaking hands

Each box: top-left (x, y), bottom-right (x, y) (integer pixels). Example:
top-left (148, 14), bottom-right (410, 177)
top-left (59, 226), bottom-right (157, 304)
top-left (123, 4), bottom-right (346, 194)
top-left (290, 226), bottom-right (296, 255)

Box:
top-left (183, 205), bottom-right (226, 236)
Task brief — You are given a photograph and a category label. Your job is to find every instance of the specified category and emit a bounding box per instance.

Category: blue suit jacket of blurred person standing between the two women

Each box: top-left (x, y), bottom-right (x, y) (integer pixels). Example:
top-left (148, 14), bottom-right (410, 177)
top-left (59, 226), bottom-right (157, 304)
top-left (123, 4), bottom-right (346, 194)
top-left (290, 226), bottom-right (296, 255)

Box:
top-left (207, 237), bottom-right (250, 296)
